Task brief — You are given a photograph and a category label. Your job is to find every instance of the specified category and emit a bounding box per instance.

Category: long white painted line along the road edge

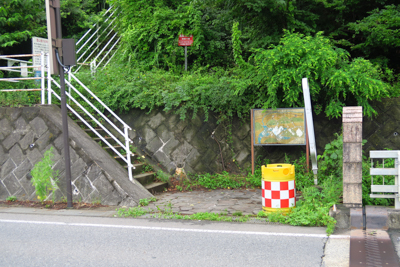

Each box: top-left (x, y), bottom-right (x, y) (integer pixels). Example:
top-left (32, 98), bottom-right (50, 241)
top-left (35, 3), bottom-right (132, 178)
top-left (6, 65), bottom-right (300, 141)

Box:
top-left (0, 219), bottom-right (350, 239)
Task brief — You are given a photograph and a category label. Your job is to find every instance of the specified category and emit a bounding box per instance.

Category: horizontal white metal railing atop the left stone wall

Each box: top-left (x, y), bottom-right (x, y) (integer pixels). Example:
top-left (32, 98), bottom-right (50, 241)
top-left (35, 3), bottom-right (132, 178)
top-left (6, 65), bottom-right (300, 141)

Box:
top-left (0, 52), bottom-right (46, 105)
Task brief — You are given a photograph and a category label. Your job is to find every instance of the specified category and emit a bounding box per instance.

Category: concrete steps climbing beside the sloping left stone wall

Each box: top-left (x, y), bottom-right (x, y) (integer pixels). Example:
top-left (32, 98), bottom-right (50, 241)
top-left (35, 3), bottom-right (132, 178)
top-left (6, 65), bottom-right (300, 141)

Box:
top-left (69, 107), bottom-right (168, 194)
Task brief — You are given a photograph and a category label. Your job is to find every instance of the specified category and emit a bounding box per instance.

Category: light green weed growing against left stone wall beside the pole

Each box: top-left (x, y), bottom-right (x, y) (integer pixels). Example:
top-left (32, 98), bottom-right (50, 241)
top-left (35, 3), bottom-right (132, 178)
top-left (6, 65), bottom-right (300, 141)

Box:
top-left (31, 147), bottom-right (58, 202)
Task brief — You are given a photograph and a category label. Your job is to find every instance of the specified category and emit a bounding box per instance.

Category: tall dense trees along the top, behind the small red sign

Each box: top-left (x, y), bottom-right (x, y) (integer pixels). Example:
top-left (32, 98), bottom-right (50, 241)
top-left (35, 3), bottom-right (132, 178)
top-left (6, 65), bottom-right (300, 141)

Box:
top-left (109, 0), bottom-right (399, 73)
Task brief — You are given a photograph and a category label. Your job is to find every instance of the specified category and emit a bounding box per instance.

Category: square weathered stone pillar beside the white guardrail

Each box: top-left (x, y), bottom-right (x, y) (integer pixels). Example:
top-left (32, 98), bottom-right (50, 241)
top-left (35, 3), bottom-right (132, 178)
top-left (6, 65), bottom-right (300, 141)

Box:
top-left (342, 107), bottom-right (363, 208)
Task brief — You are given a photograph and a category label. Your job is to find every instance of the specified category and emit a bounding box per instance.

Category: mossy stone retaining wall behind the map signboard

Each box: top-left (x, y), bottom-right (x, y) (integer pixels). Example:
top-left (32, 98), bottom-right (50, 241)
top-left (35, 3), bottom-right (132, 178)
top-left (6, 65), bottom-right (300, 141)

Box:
top-left (121, 98), bottom-right (400, 176)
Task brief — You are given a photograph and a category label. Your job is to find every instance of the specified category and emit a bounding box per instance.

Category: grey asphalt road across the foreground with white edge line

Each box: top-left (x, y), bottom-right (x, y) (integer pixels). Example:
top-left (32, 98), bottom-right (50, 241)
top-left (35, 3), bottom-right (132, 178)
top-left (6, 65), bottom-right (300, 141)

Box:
top-left (0, 213), bottom-right (348, 267)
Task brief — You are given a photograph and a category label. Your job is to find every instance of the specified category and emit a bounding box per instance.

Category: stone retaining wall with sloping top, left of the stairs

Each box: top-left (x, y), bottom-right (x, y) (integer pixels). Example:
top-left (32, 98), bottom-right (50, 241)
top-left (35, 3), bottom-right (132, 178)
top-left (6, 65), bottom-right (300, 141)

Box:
top-left (0, 106), bottom-right (152, 206)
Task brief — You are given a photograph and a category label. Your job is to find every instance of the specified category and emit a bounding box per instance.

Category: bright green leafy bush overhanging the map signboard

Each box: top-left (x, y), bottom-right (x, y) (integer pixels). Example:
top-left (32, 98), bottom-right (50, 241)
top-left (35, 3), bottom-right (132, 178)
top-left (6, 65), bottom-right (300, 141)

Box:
top-left (233, 28), bottom-right (391, 118)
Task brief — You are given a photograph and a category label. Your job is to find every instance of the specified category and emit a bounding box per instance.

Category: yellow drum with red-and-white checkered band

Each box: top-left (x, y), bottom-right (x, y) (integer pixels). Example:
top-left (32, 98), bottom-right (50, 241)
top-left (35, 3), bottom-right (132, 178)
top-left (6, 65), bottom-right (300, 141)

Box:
top-left (261, 164), bottom-right (296, 212)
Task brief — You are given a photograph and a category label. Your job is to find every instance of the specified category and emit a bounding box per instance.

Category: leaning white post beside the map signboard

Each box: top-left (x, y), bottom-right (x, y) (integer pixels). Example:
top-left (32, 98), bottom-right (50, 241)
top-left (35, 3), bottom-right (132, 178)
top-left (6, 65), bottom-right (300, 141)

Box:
top-left (301, 78), bottom-right (318, 184)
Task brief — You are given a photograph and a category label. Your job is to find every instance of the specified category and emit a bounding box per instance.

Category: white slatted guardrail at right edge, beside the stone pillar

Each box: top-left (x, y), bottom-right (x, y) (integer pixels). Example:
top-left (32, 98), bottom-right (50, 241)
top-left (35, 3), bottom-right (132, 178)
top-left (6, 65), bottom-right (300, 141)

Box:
top-left (369, 150), bottom-right (400, 209)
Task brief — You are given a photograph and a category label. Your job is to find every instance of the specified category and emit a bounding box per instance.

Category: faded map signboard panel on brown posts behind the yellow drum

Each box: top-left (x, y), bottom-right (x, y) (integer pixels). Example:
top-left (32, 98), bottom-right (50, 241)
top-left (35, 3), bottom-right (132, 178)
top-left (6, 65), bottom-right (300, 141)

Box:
top-left (252, 108), bottom-right (306, 146)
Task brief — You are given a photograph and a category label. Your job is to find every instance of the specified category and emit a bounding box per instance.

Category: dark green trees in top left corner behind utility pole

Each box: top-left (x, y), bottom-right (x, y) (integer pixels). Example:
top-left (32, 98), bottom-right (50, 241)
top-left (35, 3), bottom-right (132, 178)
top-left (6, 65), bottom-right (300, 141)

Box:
top-left (0, 0), bottom-right (105, 55)
